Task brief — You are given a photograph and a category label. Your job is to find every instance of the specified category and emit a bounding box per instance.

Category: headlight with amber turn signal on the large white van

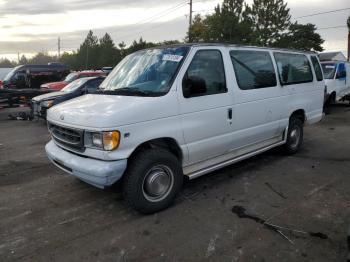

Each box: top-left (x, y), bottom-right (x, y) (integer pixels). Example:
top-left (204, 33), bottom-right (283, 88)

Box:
top-left (85, 131), bottom-right (120, 151)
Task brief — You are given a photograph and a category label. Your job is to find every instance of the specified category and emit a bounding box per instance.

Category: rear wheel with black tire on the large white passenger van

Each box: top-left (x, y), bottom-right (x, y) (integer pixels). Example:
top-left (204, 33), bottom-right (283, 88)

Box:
top-left (283, 117), bottom-right (304, 155)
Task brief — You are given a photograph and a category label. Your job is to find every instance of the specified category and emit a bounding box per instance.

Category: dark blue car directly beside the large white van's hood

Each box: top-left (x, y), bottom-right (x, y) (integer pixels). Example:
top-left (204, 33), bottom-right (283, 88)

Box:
top-left (31, 76), bottom-right (105, 118)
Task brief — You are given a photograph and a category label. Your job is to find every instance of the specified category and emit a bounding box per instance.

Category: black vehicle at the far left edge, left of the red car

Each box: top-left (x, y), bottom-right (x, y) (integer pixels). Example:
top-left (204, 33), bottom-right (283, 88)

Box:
top-left (0, 63), bottom-right (70, 106)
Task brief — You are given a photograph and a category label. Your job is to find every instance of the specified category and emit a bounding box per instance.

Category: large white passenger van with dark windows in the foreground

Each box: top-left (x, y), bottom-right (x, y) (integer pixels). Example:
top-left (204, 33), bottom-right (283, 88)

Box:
top-left (46, 44), bottom-right (325, 213)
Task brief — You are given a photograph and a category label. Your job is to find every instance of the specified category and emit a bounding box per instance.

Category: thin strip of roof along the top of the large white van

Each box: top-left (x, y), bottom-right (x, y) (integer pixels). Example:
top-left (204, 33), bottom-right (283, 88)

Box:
top-left (147, 42), bottom-right (317, 54)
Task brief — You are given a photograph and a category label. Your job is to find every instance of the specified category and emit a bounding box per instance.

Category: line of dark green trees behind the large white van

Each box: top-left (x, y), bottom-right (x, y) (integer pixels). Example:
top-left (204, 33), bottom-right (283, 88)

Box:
top-left (0, 0), bottom-right (324, 70)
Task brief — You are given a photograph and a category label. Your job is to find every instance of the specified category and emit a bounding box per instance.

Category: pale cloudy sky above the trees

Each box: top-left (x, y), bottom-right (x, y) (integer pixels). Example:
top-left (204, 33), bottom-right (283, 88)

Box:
top-left (0, 0), bottom-right (350, 60)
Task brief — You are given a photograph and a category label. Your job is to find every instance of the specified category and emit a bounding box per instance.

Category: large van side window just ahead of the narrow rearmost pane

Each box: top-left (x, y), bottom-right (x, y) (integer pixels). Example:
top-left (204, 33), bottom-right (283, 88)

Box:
top-left (274, 53), bottom-right (313, 85)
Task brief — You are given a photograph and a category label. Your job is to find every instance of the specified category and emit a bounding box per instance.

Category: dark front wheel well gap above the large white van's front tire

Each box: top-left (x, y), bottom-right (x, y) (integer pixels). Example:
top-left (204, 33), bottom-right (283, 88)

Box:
top-left (130, 137), bottom-right (183, 162)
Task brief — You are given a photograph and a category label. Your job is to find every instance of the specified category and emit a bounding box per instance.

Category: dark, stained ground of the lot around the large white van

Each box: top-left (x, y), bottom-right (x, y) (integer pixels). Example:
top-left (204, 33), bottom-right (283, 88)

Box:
top-left (0, 105), bottom-right (350, 262)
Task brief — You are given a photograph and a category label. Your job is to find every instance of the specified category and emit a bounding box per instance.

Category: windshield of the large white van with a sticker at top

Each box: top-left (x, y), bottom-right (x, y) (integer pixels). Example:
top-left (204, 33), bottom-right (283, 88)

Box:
top-left (100, 46), bottom-right (189, 96)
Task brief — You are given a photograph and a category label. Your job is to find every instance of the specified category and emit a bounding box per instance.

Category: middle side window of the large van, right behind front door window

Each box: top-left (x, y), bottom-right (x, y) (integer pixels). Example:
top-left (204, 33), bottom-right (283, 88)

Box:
top-left (230, 50), bottom-right (277, 90)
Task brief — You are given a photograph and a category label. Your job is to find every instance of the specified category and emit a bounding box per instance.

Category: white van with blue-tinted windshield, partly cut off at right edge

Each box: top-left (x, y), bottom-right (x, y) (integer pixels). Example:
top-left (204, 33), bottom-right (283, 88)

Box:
top-left (321, 61), bottom-right (350, 104)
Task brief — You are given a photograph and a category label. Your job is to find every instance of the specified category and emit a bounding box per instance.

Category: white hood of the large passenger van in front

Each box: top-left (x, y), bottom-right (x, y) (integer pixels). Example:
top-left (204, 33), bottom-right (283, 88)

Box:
top-left (47, 92), bottom-right (178, 130)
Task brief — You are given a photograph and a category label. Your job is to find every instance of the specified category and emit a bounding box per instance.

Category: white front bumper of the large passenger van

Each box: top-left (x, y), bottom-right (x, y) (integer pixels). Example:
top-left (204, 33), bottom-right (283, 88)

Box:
top-left (45, 140), bottom-right (127, 188)
